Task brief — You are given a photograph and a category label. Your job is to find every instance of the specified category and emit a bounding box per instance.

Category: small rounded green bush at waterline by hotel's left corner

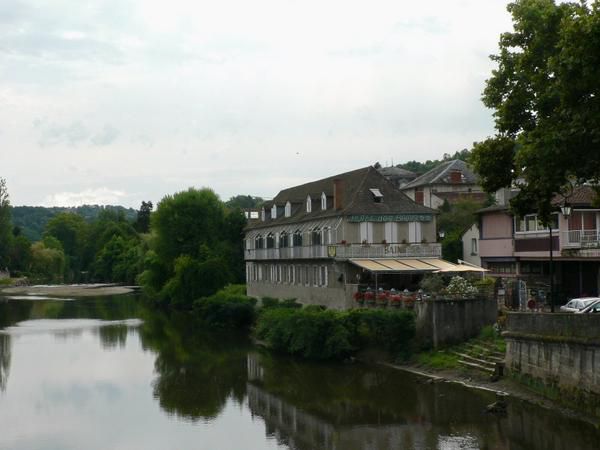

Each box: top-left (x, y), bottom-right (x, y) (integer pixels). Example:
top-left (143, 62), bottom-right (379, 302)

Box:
top-left (194, 285), bottom-right (256, 329)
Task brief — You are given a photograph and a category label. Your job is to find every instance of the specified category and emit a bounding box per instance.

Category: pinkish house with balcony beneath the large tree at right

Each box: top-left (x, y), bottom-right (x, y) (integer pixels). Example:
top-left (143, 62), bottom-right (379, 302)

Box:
top-left (478, 186), bottom-right (600, 303)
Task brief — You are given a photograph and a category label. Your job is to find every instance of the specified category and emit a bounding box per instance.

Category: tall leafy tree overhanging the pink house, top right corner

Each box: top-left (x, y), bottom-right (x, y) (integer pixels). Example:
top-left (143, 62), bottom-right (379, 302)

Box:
top-left (472, 0), bottom-right (600, 222)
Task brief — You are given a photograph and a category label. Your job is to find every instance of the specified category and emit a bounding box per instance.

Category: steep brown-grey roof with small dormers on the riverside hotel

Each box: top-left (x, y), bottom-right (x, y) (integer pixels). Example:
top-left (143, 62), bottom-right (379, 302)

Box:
top-left (246, 166), bottom-right (437, 229)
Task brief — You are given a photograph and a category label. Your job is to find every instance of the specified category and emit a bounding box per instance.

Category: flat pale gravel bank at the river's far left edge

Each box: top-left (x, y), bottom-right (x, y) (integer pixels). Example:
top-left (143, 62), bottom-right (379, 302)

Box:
top-left (0, 284), bottom-right (136, 297)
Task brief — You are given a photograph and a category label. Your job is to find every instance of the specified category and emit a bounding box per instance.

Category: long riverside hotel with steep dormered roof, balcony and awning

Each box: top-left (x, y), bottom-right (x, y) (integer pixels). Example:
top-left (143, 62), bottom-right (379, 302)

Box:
top-left (244, 167), bottom-right (449, 309)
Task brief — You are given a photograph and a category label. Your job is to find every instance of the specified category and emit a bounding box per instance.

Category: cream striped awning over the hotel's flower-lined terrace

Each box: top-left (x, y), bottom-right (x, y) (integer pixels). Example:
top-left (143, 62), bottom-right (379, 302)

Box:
top-left (350, 258), bottom-right (487, 273)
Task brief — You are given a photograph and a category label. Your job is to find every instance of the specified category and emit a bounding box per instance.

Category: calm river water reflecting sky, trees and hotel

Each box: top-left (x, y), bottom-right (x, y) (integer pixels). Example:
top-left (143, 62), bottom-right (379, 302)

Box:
top-left (0, 296), bottom-right (600, 450)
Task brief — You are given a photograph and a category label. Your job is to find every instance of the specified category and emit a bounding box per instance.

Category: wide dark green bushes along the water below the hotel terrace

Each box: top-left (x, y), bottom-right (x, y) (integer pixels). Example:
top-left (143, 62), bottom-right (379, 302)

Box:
top-left (256, 307), bottom-right (415, 360)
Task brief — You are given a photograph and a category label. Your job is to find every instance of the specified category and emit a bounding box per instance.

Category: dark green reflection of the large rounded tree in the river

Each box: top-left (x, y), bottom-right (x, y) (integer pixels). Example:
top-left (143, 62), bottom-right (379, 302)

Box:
top-left (141, 314), bottom-right (250, 422)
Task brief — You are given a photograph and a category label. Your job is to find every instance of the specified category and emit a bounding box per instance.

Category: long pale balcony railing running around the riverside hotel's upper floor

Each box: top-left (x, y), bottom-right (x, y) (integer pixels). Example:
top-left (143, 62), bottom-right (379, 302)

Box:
top-left (246, 243), bottom-right (442, 260)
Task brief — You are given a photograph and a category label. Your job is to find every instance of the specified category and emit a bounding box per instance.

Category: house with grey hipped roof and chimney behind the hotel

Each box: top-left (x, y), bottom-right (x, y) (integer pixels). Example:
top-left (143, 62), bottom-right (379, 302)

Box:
top-left (400, 159), bottom-right (487, 209)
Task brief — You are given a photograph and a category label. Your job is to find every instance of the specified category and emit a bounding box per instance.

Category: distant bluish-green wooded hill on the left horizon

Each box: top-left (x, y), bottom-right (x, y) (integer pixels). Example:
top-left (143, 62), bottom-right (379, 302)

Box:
top-left (11, 205), bottom-right (137, 242)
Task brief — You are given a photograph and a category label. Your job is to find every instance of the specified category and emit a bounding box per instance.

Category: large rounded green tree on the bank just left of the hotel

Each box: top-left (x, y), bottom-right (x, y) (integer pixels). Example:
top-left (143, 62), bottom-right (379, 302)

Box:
top-left (139, 188), bottom-right (243, 307)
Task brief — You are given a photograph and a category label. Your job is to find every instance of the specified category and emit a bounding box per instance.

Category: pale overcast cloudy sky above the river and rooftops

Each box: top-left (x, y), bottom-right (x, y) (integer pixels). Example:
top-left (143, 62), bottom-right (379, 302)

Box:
top-left (0, 0), bottom-right (511, 207)
